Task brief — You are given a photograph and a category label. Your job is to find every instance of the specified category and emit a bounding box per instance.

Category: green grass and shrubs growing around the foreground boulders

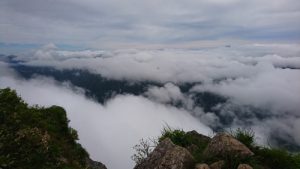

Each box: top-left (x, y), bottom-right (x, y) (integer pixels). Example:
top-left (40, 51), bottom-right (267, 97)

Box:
top-left (158, 126), bottom-right (300, 169)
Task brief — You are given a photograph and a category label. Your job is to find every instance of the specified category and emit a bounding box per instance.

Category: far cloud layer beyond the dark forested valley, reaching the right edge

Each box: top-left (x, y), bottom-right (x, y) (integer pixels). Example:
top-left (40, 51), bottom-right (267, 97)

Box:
top-left (20, 43), bottom-right (300, 148)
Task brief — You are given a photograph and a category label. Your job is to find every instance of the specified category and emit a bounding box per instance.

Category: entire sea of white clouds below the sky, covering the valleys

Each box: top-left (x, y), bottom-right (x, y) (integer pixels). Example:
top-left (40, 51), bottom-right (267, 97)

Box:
top-left (0, 44), bottom-right (300, 168)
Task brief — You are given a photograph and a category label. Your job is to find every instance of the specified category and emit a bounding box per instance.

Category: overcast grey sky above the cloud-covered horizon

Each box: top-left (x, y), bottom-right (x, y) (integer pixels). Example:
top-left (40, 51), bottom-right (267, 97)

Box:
top-left (0, 0), bottom-right (300, 50)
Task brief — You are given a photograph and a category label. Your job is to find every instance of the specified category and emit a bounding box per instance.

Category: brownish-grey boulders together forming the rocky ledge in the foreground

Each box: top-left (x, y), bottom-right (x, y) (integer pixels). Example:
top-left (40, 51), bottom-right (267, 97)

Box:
top-left (134, 131), bottom-right (254, 169)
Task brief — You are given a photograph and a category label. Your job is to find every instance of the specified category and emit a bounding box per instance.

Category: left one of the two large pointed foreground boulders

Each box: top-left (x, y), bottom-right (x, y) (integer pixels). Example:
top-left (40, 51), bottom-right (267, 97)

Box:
top-left (134, 138), bottom-right (195, 169)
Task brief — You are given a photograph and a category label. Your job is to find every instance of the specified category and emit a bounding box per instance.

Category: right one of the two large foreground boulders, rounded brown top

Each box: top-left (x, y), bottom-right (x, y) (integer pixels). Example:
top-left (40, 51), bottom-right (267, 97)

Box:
top-left (204, 133), bottom-right (254, 158)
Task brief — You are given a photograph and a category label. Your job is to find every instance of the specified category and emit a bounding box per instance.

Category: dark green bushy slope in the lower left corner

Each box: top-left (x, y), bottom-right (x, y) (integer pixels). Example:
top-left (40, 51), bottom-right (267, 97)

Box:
top-left (0, 88), bottom-right (89, 169)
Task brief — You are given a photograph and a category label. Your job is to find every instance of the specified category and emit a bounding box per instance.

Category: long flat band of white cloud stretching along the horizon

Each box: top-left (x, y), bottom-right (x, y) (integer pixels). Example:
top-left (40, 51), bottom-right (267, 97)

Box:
top-left (18, 44), bottom-right (300, 83)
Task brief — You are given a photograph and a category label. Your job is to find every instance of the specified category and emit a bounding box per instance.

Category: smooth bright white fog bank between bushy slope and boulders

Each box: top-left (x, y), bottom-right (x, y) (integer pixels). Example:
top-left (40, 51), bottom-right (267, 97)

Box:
top-left (0, 72), bottom-right (212, 168)
